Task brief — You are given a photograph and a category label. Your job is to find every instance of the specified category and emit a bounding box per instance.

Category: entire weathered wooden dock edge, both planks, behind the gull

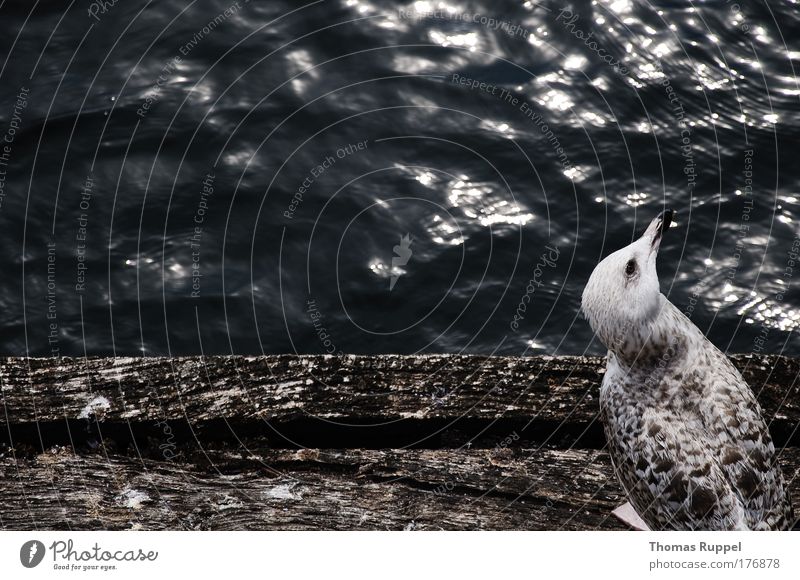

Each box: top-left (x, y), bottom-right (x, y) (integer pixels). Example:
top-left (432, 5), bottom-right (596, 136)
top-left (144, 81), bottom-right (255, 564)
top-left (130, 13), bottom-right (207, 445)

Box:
top-left (0, 355), bottom-right (800, 530)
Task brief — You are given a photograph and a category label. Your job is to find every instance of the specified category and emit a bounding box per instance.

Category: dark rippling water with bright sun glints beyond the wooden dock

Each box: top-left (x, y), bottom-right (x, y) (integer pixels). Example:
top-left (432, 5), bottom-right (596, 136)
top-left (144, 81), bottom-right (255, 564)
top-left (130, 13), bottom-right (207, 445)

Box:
top-left (0, 0), bottom-right (800, 355)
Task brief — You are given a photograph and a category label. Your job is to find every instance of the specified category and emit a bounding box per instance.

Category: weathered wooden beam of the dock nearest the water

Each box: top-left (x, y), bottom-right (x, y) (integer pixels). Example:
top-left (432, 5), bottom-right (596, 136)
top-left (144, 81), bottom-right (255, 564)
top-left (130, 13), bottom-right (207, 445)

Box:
top-left (0, 355), bottom-right (800, 423)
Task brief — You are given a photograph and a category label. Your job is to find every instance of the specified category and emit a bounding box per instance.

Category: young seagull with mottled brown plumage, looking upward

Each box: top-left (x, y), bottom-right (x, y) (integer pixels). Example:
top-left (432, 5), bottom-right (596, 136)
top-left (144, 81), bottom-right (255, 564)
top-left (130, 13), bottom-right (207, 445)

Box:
top-left (581, 210), bottom-right (794, 530)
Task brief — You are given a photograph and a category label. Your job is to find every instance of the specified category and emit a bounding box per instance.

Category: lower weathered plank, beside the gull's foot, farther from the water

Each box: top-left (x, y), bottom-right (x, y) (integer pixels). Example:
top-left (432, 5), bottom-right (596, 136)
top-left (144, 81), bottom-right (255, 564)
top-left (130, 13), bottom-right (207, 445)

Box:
top-left (0, 449), bottom-right (800, 530)
